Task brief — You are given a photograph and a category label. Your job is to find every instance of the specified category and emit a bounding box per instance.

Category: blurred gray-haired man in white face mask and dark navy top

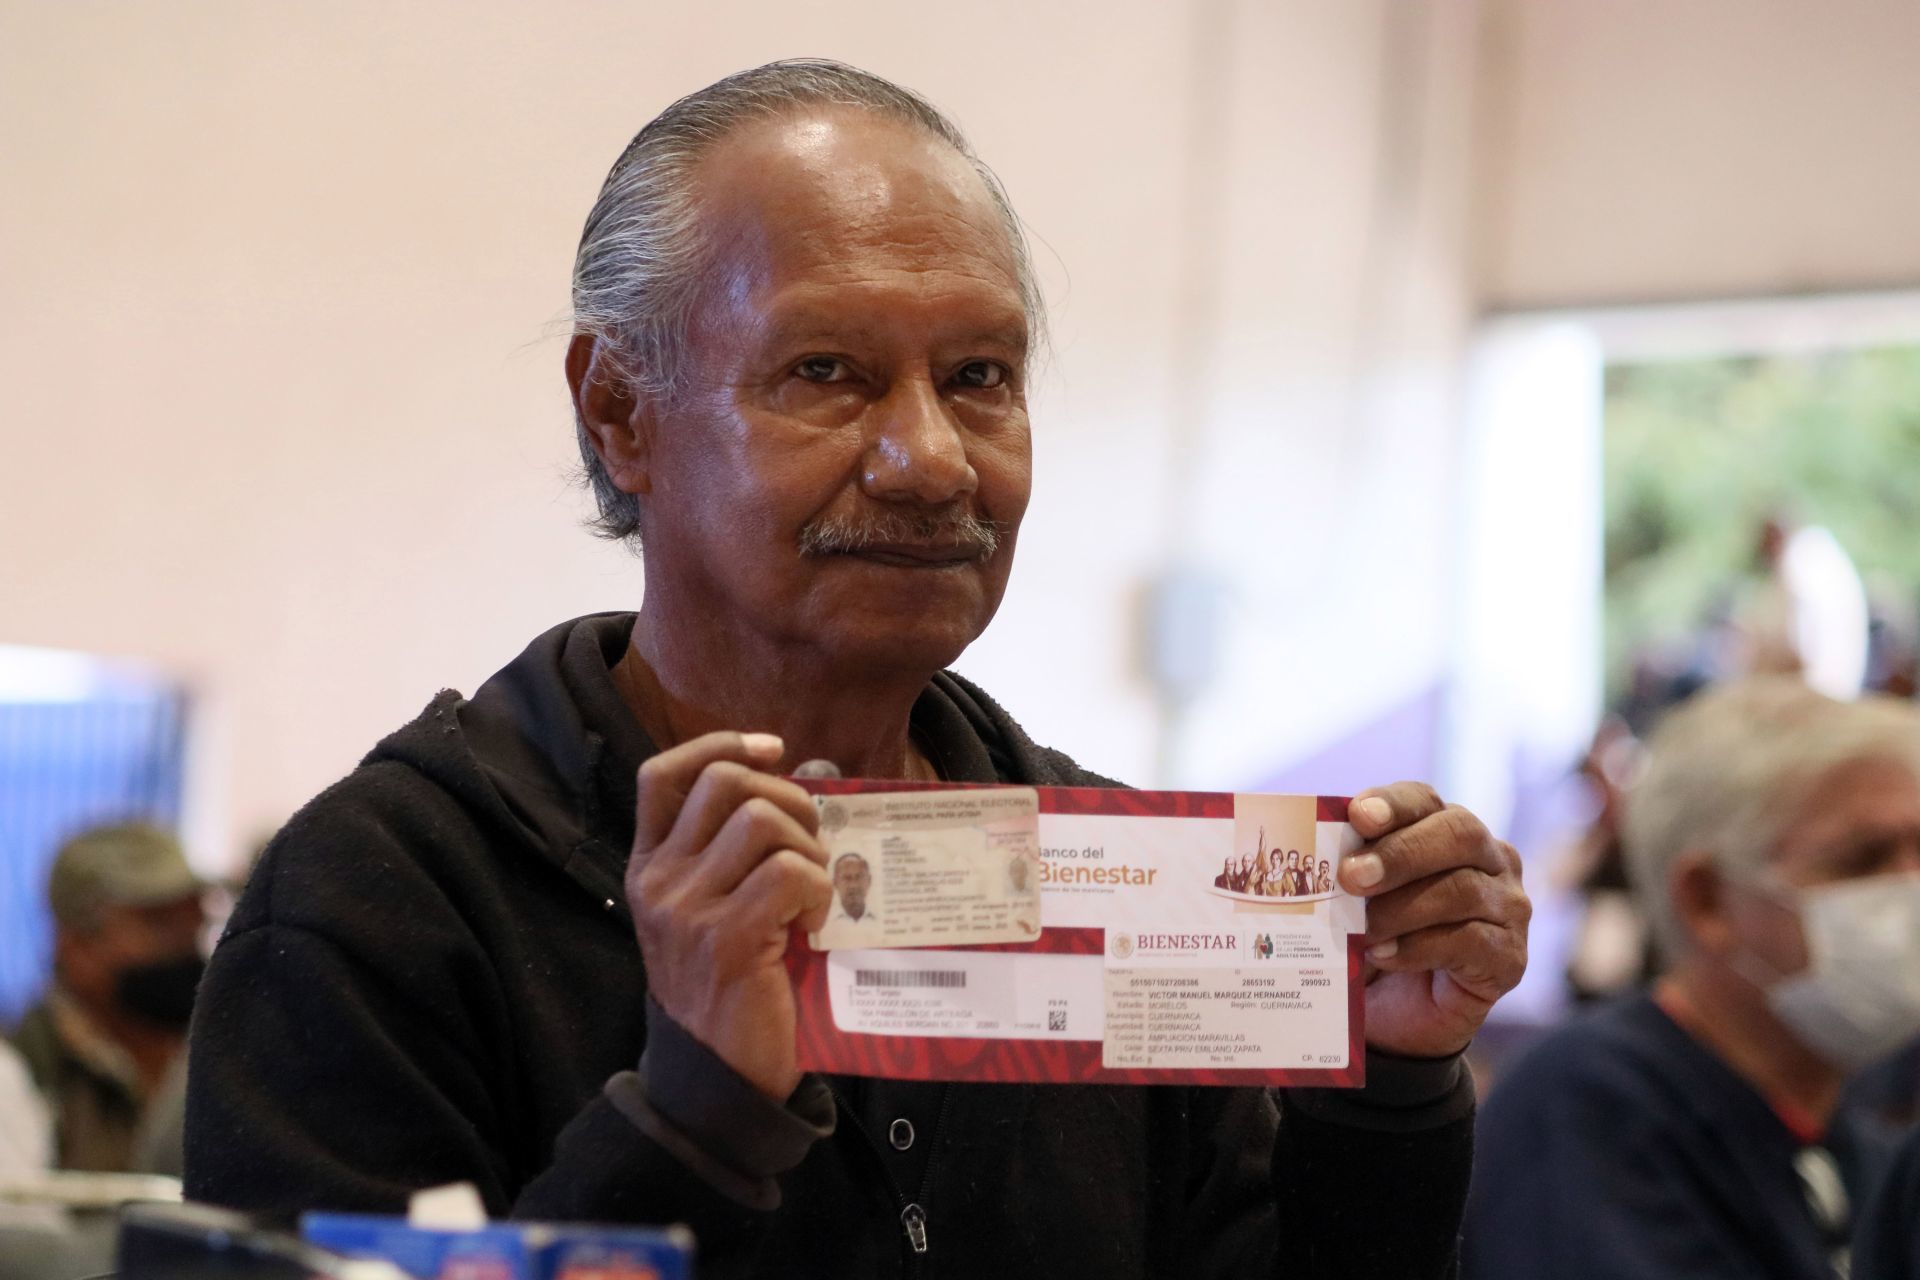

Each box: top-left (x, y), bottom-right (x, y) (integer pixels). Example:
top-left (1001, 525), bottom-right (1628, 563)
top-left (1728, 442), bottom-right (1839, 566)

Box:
top-left (1463, 677), bottom-right (1920, 1280)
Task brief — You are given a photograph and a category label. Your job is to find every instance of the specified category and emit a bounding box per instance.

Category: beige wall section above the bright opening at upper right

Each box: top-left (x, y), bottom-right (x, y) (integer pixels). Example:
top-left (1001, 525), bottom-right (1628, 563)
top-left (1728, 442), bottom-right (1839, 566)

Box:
top-left (1480, 0), bottom-right (1920, 307)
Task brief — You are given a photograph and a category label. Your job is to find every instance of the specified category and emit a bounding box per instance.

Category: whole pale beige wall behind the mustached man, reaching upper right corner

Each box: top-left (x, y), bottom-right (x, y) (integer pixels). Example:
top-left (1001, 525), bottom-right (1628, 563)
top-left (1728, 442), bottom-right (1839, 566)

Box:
top-left (18, 0), bottom-right (1920, 860)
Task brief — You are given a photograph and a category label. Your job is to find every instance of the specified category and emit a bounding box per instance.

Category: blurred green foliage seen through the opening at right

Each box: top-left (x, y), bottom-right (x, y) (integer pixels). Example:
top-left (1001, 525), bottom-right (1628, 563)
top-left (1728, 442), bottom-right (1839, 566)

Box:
top-left (1605, 347), bottom-right (1920, 702)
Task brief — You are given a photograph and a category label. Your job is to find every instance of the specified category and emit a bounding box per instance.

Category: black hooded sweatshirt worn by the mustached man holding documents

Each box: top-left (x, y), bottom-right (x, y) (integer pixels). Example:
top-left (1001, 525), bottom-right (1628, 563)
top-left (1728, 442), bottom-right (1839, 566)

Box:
top-left (186, 614), bottom-right (1473, 1280)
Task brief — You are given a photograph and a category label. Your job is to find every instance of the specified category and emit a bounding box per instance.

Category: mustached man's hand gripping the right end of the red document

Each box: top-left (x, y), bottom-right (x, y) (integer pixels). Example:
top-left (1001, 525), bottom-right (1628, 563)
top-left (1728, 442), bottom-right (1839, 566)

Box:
top-left (1340, 783), bottom-right (1534, 1057)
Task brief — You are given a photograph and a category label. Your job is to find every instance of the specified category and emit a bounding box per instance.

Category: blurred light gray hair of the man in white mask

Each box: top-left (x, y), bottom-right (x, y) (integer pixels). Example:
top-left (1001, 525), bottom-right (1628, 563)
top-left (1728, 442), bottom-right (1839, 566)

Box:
top-left (1620, 676), bottom-right (1920, 961)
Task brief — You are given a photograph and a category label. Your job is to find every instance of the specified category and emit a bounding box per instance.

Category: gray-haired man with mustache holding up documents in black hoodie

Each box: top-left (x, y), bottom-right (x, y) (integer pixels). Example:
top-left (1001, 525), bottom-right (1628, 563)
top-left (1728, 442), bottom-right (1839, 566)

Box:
top-left (188, 63), bottom-right (1526, 1280)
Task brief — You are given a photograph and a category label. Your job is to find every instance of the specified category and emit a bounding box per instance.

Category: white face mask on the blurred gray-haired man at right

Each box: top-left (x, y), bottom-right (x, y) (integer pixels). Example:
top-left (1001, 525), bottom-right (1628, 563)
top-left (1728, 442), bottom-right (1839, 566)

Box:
top-left (1766, 871), bottom-right (1920, 1071)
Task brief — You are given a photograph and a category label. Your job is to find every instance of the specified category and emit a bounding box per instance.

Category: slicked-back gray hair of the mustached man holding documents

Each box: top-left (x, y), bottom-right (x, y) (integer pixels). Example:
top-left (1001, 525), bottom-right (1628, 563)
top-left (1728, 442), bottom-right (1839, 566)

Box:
top-left (574, 58), bottom-right (1043, 541)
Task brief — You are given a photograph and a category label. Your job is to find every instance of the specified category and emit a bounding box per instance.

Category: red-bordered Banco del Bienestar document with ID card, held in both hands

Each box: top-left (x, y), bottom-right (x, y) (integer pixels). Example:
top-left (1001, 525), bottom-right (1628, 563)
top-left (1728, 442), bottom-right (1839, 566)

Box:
top-left (787, 779), bottom-right (1367, 1086)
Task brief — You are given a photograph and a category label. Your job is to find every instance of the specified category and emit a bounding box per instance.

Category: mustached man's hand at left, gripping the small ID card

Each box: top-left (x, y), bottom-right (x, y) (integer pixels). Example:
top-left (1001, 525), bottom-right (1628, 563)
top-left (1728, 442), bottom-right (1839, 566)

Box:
top-left (626, 733), bottom-right (833, 1102)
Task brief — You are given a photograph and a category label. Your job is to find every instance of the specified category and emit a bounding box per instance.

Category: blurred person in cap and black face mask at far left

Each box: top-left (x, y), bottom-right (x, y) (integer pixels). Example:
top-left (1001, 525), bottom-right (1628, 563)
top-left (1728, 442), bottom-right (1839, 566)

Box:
top-left (13, 823), bottom-right (205, 1173)
